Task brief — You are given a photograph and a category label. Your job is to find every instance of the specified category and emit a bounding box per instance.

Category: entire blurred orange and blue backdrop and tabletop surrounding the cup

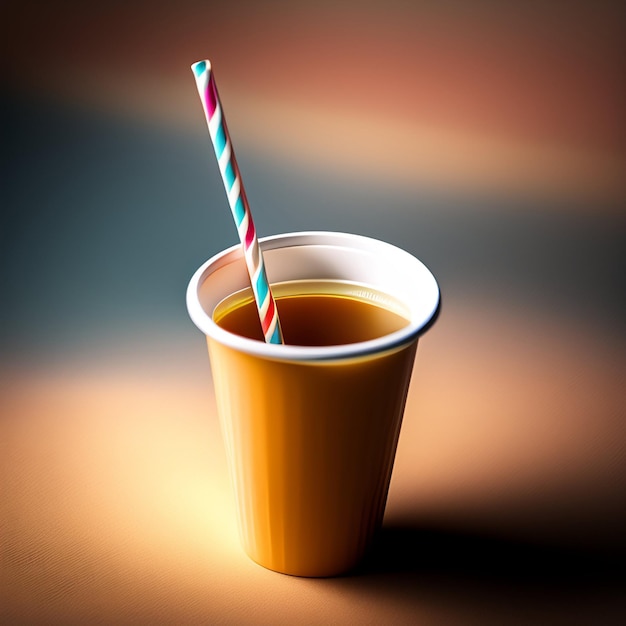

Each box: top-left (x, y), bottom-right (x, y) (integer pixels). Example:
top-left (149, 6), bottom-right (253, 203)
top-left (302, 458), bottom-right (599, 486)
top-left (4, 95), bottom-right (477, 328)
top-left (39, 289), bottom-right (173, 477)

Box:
top-left (0, 0), bottom-right (626, 624)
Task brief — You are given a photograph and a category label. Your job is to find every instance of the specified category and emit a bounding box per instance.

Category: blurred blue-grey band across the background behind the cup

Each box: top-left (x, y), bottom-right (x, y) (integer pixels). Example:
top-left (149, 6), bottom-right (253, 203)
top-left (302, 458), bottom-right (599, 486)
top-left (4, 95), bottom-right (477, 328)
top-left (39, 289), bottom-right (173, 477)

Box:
top-left (0, 89), bottom-right (626, 359)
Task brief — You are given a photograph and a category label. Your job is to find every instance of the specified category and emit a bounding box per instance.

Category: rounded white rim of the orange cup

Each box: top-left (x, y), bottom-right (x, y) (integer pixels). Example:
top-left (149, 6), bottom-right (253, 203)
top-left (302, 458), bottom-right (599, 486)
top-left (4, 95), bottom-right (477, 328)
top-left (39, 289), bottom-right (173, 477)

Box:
top-left (186, 231), bottom-right (441, 362)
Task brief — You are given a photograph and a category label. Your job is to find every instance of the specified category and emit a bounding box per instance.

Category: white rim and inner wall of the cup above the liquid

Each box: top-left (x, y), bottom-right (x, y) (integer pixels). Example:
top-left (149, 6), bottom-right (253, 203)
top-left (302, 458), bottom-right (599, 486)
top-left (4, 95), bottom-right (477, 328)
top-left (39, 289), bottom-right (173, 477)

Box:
top-left (187, 232), bottom-right (440, 360)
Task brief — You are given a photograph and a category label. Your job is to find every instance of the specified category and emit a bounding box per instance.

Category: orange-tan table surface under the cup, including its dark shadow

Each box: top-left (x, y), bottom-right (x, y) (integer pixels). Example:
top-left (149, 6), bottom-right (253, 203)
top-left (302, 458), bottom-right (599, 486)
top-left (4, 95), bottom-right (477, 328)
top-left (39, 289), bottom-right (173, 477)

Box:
top-left (0, 302), bottom-right (624, 624)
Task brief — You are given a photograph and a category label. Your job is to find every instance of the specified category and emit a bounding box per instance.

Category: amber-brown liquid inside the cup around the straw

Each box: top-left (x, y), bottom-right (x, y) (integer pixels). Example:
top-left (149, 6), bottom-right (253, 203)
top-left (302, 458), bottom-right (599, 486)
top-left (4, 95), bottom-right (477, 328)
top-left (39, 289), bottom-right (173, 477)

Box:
top-left (213, 281), bottom-right (408, 346)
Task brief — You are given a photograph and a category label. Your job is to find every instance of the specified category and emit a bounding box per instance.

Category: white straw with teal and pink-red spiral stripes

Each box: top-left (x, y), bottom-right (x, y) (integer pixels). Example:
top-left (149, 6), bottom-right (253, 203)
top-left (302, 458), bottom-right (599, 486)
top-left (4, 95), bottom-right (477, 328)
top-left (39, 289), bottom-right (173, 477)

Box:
top-left (191, 60), bottom-right (283, 343)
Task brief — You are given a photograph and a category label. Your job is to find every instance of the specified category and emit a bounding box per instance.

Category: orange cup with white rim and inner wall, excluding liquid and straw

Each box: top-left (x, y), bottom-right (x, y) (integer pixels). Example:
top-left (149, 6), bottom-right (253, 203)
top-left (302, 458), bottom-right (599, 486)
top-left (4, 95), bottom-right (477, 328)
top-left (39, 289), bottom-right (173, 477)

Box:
top-left (187, 232), bottom-right (439, 576)
